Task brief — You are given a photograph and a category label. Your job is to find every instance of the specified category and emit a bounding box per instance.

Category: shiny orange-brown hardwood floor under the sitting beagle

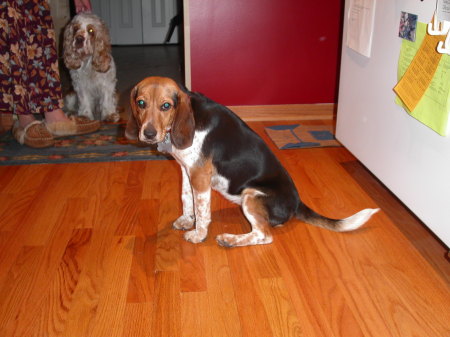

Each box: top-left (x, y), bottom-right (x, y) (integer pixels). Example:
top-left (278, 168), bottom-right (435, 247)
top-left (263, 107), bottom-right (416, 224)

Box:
top-left (0, 121), bottom-right (450, 337)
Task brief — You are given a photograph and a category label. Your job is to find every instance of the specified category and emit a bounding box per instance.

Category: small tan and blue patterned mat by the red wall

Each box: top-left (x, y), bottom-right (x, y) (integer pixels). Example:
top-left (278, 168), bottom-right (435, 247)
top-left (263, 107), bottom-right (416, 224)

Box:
top-left (265, 124), bottom-right (341, 150)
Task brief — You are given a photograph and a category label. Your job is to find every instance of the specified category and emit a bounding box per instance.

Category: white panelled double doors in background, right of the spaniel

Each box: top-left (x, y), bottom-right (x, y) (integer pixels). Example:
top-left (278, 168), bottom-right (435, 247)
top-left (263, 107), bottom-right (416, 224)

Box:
top-left (91, 0), bottom-right (181, 45)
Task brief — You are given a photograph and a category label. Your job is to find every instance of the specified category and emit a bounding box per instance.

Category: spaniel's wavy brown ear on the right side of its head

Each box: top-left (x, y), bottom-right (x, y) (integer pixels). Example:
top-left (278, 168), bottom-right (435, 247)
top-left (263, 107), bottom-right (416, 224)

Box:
top-left (92, 20), bottom-right (111, 73)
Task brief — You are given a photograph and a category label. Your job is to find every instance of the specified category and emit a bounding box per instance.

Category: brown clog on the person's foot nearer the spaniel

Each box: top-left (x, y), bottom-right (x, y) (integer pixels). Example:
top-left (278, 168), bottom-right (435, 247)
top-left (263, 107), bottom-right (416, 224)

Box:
top-left (46, 116), bottom-right (100, 138)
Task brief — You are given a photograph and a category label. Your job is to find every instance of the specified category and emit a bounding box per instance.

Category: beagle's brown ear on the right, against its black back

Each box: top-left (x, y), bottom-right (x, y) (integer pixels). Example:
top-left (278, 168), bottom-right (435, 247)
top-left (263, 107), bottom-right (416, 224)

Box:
top-left (171, 91), bottom-right (195, 150)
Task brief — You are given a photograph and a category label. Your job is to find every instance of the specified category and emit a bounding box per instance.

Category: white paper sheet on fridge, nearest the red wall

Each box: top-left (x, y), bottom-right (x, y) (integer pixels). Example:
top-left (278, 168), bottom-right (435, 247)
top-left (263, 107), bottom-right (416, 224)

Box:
top-left (346, 0), bottom-right (376, 57)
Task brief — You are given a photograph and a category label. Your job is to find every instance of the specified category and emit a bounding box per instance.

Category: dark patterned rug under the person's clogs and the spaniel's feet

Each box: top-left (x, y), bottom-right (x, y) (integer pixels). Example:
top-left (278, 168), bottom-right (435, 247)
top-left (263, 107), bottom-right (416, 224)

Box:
top-left (0, 121), bottom-right (170, 165)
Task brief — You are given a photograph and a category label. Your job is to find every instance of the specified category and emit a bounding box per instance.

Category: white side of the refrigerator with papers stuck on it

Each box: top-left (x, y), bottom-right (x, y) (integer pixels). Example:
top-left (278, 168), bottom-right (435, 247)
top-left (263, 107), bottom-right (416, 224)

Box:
top-left (337, 0), bottom-right (450, 246)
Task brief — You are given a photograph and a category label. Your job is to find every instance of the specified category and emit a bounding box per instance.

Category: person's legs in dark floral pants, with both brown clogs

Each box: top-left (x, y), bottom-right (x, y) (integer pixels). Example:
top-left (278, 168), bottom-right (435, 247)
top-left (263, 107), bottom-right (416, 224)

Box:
top-left (6, 0), bottom-right (100, 147)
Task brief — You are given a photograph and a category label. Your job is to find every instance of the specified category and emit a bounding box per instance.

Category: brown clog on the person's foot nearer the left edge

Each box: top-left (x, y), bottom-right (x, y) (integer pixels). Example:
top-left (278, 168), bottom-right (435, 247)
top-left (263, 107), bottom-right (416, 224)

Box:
top-left (12, 121), bottom-right (55, 148)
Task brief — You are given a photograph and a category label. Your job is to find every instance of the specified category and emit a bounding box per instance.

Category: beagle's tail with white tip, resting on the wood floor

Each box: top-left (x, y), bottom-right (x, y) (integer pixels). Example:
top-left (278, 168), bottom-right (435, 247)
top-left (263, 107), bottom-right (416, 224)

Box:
top-left (295, 203), bottom-right (380, 232)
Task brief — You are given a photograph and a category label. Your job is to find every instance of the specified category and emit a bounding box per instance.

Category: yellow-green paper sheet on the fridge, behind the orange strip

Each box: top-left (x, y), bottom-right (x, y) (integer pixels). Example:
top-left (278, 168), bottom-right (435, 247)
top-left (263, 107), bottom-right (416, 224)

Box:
top-left (394, 22), bottom-right (450, 136)
